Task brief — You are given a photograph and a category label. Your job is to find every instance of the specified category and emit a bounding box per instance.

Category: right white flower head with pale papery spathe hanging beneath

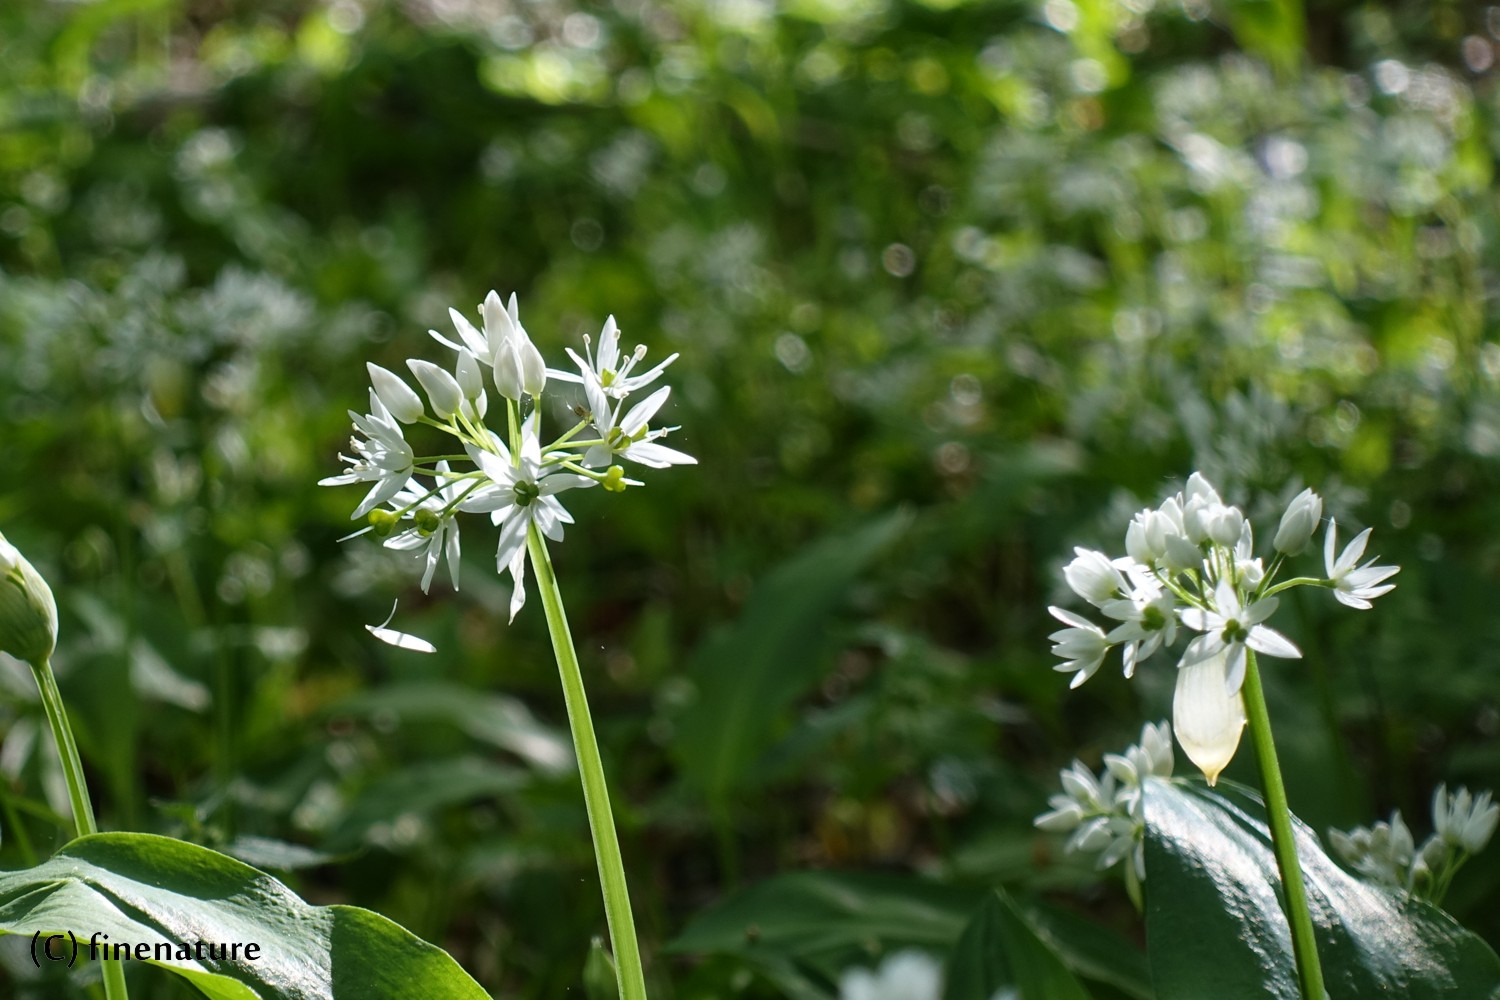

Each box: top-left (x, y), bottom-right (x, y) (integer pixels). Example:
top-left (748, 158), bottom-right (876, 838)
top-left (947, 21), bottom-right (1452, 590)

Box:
top-left (1049, 472), bottom-right (1398, 784)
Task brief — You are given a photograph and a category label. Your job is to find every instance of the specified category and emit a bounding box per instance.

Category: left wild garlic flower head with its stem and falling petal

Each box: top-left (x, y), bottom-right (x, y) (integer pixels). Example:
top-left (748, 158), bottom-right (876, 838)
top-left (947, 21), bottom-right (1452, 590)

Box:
top-left (321, 291), bottom-right (698, 1000)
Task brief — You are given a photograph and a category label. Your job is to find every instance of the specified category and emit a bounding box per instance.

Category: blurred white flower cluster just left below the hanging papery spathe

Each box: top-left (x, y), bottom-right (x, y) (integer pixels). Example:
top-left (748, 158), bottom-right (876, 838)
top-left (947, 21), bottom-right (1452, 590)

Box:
top-left (1035, 723), bottom-right (1172, 882)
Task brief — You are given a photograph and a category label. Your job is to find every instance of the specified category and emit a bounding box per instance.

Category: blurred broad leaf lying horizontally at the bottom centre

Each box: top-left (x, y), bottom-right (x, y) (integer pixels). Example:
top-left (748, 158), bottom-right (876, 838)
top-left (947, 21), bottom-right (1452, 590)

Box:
top-left (671, 871), bottom-right (980, 981)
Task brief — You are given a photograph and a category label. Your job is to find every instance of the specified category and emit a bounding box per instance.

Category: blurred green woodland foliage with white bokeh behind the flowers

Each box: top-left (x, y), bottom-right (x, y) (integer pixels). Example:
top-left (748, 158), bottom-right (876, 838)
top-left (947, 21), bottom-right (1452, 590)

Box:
top-left (0, 0), bottom-right (1500, 997)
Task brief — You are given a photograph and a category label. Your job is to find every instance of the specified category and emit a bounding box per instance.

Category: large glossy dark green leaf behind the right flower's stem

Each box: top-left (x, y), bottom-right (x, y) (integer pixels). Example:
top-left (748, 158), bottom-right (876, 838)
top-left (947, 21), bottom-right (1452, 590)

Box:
top-left (1146, 780), bottom-right (1500, 1000)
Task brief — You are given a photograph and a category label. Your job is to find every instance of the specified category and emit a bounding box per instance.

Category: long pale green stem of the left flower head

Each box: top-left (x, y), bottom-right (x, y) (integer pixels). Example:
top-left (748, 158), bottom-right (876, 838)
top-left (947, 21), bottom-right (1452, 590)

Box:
top-left (527, 523), bottom-right (647, 1000)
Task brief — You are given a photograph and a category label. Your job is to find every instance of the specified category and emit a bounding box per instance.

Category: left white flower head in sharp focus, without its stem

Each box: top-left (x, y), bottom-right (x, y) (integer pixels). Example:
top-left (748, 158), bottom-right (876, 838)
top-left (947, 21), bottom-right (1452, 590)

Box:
top-left (321, 291), bottom-right (698, 619)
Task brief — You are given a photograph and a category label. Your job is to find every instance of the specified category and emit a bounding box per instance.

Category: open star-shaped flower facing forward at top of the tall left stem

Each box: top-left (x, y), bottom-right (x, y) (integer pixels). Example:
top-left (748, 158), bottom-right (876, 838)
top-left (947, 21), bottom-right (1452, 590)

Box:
top-left (459, 411), bottom-right (594, 621)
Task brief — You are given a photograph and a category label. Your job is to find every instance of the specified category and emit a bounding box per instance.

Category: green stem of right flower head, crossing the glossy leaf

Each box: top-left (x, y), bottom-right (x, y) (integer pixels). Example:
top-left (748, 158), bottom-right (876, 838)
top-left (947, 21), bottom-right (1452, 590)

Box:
top-left (1244, 649), bottom-right (1328, 1000)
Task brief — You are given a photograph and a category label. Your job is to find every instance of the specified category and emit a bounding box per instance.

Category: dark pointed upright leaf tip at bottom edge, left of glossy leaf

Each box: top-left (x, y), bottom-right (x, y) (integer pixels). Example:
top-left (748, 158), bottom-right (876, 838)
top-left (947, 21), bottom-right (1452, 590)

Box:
top-left (944, 889), bottom-right (1089, 1000)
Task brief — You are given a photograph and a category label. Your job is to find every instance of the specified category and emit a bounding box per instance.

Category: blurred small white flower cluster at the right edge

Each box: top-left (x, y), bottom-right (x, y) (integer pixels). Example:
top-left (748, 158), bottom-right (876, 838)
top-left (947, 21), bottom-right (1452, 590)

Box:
top-left (1329, 786), bottom-right (1500, 903)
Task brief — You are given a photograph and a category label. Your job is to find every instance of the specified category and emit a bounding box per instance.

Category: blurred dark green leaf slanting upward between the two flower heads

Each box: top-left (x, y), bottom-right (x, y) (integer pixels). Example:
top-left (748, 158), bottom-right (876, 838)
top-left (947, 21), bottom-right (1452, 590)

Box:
top-left (674, 514), bottom-right (909, 802)
